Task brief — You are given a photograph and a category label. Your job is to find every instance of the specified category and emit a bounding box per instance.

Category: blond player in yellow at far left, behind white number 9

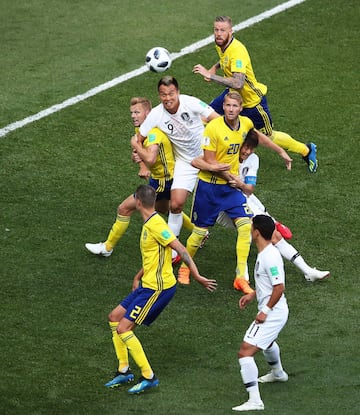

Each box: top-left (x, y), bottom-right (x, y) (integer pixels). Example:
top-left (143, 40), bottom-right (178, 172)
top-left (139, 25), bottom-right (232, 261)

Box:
top-left (85, 97), bottom-right (193, 260)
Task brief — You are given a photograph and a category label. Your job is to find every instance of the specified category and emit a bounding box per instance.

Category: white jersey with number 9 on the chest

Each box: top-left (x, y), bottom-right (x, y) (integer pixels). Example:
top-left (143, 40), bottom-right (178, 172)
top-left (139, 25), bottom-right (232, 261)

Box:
top-left (139, 95), bottom-right (214, 163)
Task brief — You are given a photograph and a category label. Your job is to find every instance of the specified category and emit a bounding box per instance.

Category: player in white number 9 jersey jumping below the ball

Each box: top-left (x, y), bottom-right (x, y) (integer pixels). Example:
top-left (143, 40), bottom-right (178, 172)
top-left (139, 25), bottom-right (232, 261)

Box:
top-left (138, 75), bottom-right (218, 256)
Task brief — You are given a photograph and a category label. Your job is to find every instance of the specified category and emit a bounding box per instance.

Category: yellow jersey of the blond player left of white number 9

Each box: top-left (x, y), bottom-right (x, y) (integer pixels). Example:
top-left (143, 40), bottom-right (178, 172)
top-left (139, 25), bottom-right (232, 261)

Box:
top-left (143, 128), bottom-right (175, 181)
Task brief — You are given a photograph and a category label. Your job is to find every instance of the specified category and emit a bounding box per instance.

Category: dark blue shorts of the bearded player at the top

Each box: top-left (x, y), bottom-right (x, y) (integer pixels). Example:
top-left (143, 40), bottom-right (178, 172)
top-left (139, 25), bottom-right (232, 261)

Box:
top-left (210, 89), bottom-right (273, 136)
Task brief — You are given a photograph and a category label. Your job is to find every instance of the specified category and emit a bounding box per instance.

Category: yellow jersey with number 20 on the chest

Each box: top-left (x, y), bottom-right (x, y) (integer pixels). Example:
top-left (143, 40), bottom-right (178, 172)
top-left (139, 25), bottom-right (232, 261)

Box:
top-left (199, 115), bottom-right (254, 184)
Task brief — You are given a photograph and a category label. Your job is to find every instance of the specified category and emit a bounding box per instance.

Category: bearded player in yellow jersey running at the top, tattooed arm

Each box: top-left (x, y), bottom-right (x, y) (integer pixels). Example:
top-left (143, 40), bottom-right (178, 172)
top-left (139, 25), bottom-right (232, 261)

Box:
top-left (193, 16), bottom-right (318, 173)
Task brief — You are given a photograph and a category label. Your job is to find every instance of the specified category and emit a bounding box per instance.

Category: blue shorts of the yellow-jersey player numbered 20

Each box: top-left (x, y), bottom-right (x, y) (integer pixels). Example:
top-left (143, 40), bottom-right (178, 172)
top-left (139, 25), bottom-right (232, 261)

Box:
top-left (192, 179), bottom-right (253, 228)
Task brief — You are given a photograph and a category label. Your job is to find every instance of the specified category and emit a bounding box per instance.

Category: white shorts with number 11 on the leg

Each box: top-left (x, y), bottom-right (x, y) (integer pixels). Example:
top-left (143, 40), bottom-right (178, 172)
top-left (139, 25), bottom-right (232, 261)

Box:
top-left (243, 307), bottom-right (289, 350)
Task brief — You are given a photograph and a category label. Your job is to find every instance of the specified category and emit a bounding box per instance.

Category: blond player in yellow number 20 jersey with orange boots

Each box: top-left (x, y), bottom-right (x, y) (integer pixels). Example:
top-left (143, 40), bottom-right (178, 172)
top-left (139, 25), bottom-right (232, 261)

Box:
top-left (178, 92), bottom-right (291, 292)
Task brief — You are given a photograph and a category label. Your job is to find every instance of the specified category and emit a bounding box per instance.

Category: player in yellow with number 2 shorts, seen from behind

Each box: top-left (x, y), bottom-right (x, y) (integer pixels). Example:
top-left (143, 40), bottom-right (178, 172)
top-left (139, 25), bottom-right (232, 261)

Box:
top-left (105, 185), bottom-right (217, 394)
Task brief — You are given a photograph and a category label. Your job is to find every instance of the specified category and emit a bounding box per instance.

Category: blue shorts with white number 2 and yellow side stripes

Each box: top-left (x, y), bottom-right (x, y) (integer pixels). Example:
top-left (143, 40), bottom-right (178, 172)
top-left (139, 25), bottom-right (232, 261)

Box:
top-left (120, 284), bottom-right (176, 326)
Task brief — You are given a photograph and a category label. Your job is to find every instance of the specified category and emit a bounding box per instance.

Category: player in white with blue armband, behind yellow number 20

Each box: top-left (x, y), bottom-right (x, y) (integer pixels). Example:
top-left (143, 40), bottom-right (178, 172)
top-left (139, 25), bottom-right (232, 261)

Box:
top-left (194, 130), bottom-right (330, 282)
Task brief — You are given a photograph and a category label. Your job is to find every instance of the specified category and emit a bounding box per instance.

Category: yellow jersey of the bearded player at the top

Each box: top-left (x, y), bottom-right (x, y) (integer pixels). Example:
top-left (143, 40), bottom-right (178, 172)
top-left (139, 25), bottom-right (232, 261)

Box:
top-left (215, 38), bottom-right (267, 108)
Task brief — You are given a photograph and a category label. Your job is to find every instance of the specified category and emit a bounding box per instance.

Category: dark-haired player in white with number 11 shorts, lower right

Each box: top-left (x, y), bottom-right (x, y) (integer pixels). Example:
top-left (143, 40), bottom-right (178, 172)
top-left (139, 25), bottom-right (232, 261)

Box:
top-left (232, 215), bottom-right (289, 412)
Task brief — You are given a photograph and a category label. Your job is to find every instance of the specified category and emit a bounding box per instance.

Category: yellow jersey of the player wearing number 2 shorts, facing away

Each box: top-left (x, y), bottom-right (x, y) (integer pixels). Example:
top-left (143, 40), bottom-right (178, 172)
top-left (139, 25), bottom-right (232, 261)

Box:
top-left (140, 212), bottom-right (176, 291)
